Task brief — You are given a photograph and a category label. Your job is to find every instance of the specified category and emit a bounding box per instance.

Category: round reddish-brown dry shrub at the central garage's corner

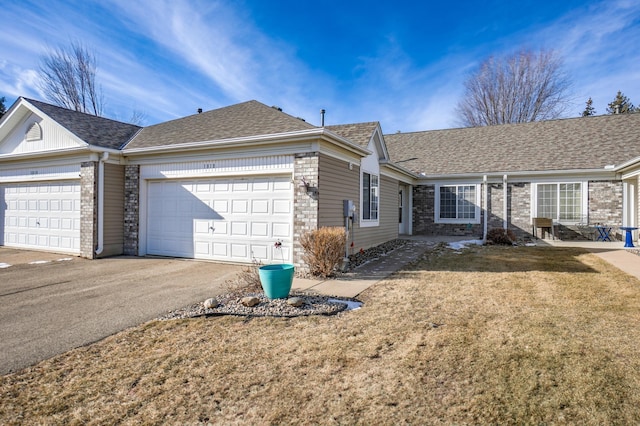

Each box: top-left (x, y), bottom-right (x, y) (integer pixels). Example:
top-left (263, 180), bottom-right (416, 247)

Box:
top-left (300, 226), bottom-right (347, 278)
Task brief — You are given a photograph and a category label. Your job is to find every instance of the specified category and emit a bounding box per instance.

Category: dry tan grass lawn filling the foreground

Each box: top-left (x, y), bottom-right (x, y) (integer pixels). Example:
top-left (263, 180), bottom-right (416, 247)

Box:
top-left (0, 246), bottom-right (640, 425)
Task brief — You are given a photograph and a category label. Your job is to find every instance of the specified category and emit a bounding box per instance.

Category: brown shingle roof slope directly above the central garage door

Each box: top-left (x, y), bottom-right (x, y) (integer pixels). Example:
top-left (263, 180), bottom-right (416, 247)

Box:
top-left (126, 101), bottom-right (316, 149)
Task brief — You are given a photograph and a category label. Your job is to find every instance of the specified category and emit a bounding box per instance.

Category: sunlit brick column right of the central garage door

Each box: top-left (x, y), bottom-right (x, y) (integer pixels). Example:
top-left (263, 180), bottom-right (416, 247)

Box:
top-left (293, 152), bottom-right (320, 272)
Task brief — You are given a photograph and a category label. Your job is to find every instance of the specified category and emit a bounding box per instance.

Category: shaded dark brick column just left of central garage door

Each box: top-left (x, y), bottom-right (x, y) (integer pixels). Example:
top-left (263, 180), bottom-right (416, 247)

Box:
top-left (124, 165), bottom-right (140, 256)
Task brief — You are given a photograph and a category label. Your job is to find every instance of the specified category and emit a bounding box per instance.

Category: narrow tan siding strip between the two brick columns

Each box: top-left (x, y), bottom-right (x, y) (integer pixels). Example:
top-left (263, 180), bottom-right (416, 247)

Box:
top-left (100, 164), bottom-right (124, 257)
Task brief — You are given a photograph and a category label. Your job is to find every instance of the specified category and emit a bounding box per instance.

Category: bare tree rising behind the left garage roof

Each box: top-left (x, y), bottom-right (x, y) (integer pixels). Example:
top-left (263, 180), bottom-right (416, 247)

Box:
top-left (40, 42), bottom-right (103, 115)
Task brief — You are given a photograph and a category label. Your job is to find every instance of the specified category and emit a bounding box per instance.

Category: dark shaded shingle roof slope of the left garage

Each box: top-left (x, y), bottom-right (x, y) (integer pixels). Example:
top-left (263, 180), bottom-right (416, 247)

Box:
top-left (24, 98), bottom-right (141, 149)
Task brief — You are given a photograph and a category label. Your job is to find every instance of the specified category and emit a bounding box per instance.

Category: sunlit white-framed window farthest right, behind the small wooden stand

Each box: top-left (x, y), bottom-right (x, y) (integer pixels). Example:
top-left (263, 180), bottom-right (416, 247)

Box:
top-left (534, 182), bottom-right (587, 222)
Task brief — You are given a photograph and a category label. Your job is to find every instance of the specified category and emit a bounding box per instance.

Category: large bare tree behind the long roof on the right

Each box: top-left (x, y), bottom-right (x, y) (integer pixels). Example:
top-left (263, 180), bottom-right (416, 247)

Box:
top-left (457, 50), bottom-right (571, 127)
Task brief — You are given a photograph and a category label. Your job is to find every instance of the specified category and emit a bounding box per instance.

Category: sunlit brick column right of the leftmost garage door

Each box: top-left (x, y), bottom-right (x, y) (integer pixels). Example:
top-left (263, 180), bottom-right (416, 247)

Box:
top-left (80, 161), bottom-right (98, 259)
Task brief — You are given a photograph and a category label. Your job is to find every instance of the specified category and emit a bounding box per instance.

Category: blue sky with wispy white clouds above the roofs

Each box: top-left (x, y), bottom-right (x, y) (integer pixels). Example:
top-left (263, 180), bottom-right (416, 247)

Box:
top-left (0, 0), bottom-right (640, 133)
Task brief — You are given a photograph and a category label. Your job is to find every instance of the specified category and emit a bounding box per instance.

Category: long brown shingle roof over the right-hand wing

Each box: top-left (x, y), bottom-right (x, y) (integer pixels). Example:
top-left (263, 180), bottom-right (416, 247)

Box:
top-left (384, 113), bottom-right (640, 175)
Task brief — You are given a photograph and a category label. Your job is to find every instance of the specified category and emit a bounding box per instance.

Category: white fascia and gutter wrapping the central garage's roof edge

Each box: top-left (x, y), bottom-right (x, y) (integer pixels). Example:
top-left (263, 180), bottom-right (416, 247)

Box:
top-left (122, 129), bottom-right (368, 156)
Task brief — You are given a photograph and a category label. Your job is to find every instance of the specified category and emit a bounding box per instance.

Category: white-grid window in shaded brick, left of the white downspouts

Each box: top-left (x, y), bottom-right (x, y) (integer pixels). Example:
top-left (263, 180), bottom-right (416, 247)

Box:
top-left (435, 185), bottom-right (480, 223)
